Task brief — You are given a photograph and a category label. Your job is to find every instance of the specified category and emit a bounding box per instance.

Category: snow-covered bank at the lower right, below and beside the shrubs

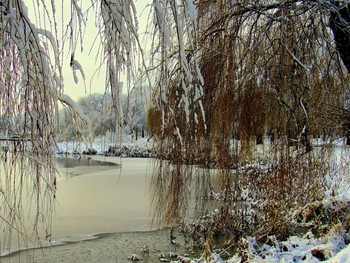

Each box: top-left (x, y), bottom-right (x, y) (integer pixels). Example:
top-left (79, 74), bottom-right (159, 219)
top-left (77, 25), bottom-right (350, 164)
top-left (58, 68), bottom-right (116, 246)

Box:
top-left (227, 145), bottom-right (350, 263)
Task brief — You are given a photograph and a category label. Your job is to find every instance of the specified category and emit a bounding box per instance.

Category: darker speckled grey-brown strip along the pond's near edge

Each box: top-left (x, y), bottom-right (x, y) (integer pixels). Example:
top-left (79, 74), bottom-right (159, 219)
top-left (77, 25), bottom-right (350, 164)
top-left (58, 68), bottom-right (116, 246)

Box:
top-left (0, 229), bottom-right (191, 263)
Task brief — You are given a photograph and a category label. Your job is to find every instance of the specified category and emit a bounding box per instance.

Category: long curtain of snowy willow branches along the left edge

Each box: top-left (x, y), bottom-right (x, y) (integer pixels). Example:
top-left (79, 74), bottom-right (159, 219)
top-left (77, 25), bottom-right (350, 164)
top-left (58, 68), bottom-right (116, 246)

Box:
top-left (0, 1), bottom-right (63, 250)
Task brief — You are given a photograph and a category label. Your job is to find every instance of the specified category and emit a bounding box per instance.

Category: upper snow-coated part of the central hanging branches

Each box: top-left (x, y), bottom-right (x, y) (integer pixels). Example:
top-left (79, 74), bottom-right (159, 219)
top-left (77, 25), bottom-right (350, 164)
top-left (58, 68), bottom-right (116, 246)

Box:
top-left (151, 0), bottom-right (205, 138)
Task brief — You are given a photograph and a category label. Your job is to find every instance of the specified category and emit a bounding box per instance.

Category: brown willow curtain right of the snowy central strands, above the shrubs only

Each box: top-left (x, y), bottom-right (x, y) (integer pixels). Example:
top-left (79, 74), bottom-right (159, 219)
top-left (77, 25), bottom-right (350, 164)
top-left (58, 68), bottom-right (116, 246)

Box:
top-left (198, 1), bottom-right (349, 157)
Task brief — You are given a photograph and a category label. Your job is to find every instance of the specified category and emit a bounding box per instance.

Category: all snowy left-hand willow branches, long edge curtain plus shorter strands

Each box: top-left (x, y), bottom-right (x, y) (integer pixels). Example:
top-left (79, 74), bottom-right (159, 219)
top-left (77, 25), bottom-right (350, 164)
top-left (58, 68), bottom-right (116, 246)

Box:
top-left (0, 0), bottom-right (145, 252)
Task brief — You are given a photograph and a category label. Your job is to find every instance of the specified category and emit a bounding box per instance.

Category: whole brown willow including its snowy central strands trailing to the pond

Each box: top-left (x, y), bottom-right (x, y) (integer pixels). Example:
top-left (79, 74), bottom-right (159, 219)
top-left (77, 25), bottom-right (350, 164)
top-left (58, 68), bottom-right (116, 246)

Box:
top-left (149, 0), bottom-right (349, 239)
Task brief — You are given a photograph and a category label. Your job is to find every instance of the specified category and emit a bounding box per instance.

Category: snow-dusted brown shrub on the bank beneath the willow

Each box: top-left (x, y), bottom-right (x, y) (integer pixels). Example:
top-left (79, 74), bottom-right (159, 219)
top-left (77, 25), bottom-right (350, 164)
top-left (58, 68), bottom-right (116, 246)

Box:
top-left (249, 151), bottom-right (327, 240)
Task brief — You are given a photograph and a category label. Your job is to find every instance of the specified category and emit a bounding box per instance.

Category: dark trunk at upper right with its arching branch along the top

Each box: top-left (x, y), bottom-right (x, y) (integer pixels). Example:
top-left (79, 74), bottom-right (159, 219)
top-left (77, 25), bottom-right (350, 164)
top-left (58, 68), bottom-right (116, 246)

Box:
top-left (200, 0), bottom-right (350, 72)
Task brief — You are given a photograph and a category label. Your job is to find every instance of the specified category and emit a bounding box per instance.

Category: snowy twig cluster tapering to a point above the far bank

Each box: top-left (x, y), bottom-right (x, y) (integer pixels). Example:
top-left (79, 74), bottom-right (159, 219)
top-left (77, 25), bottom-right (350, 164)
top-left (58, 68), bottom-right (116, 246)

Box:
top-left (100, 0), bottom-right (138, 142)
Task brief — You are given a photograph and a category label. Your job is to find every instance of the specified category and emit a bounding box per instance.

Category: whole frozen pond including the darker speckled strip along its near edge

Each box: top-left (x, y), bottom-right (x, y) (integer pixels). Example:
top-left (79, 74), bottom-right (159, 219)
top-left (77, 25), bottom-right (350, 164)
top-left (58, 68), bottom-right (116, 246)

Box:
top-left (0, 156), bottom-right (194, 263)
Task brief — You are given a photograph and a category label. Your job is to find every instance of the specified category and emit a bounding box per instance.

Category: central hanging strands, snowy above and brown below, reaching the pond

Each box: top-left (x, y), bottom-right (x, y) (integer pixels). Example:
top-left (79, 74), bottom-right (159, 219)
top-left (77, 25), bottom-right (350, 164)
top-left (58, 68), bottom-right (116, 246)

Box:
top-left (148, 0), bottom-right (205, 223)
